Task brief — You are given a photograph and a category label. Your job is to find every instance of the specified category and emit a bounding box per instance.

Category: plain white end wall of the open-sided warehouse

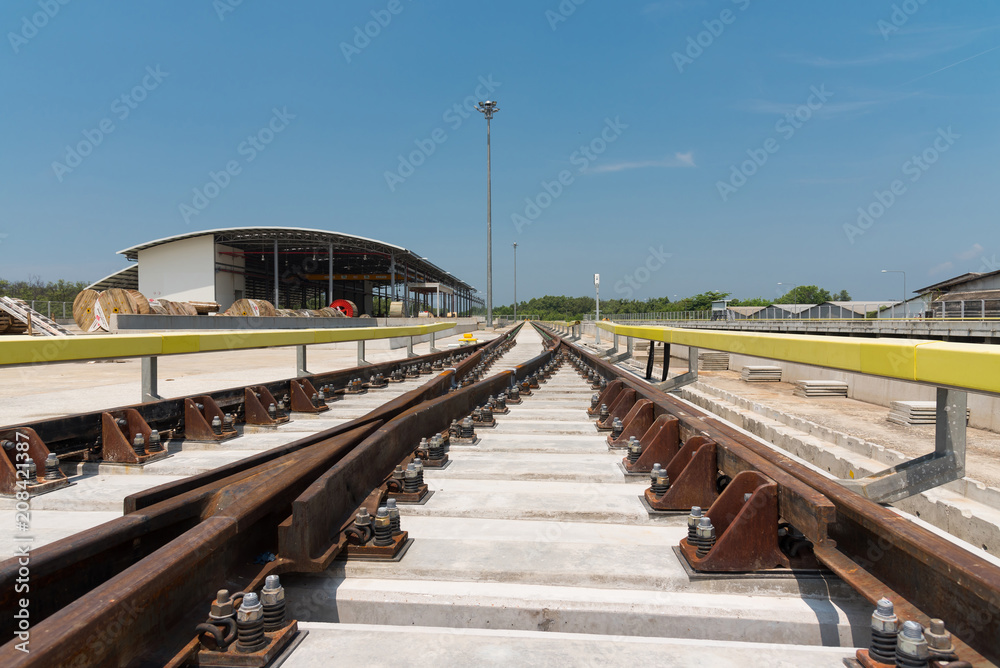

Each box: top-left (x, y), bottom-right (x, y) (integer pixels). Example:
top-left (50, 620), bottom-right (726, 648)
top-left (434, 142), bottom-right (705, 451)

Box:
top-left (139, 234), bottom-right (215, 301)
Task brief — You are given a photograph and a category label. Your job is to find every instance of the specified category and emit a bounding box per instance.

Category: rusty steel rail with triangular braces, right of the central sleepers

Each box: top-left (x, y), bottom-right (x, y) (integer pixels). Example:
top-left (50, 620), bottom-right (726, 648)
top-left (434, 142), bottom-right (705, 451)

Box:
top-left (532, 323), bottom-right (1000, 667)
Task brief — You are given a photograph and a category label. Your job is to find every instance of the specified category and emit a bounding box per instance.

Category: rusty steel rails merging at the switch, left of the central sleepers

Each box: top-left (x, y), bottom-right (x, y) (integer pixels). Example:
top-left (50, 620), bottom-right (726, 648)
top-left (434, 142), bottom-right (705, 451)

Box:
top-left (0, 327), bottom-right (540, 666)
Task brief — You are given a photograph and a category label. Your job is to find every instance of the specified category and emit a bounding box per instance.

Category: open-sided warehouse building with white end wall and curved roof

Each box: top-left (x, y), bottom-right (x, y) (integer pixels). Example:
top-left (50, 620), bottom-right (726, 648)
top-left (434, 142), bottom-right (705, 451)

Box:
top-left (90, 227), bottom-right (483, 316)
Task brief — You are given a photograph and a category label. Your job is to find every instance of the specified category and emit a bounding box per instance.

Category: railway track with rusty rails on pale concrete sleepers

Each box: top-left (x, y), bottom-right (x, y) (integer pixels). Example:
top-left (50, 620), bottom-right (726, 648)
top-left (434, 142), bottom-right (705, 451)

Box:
top-left (0, 320), bottom-right (1000, 666)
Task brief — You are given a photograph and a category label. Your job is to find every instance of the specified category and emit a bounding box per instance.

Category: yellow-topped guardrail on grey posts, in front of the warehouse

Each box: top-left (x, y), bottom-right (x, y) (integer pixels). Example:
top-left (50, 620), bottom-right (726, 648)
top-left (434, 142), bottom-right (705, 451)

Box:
top-left (0, 322), bottom-right (457, 401)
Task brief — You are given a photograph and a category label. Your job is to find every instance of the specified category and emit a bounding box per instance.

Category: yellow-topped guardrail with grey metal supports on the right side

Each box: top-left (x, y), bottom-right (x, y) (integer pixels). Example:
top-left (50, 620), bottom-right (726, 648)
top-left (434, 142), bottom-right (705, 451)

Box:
top-left (576, 322), bottom-right (1000, 503)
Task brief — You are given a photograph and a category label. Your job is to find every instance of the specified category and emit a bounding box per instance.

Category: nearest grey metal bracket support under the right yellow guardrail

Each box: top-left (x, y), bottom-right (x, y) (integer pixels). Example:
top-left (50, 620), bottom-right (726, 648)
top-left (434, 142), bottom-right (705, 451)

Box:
top-left (840, 387), bottom-right (968, 503)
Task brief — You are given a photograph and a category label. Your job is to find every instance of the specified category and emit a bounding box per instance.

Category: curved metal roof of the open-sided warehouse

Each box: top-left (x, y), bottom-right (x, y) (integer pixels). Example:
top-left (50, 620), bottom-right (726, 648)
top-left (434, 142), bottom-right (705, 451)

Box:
top-left (118, 227), bottom-right (476, 291)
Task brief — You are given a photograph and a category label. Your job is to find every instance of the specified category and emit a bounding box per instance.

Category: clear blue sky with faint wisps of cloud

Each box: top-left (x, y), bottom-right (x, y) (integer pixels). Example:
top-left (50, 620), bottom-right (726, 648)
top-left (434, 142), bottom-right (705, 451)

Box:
top-left (0, 0), bottom-right (1000, 304)
